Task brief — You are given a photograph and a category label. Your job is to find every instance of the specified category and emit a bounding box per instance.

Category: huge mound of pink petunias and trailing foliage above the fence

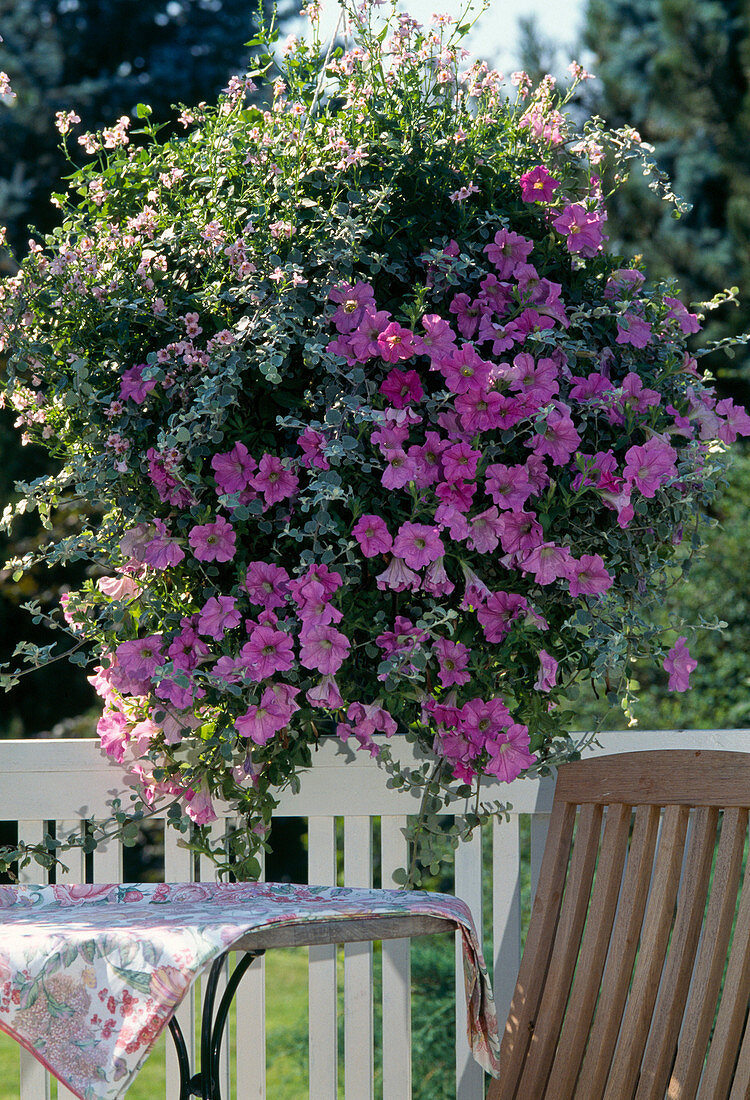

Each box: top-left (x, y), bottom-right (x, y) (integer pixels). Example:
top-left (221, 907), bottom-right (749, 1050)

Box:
top-left (1, 4), bottom-right (750, 875)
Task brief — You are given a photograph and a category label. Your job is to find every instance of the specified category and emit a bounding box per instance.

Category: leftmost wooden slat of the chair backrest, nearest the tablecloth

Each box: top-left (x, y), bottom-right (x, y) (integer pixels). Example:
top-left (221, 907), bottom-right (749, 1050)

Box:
top-left (487, 801), bottom-right (575, 1100)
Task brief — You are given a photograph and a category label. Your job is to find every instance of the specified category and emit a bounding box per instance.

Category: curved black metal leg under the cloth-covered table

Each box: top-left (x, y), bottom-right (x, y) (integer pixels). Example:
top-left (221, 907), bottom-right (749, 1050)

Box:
top-left (169, 950), bottom-right (265, 1100)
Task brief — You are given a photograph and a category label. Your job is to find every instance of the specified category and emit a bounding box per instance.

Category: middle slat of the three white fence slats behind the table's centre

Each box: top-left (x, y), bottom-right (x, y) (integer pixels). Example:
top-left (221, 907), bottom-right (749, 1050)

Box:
top-left (344, 815), bottom-right (374, 1100)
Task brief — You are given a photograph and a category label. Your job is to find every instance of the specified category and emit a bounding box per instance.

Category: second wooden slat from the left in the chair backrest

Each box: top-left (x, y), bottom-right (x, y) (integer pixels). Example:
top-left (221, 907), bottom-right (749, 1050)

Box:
top-left (519, 804), bottom-right (603, 1097)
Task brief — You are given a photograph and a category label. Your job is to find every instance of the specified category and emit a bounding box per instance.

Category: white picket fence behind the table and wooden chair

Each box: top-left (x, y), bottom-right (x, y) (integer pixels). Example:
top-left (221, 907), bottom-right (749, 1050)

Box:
top-left (0, 730), bottom-right (750, 1100)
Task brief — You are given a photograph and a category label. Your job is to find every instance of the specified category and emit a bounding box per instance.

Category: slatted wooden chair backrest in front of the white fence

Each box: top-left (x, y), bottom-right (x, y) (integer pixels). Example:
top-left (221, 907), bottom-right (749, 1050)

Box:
top-left (487, 750), bottom-right (750, 1100)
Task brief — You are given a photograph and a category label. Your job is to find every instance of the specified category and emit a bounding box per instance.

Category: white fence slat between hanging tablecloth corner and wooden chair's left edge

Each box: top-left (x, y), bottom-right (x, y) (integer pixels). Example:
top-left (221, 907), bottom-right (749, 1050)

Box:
top-left (493, 814), bottom-right (521, 1035)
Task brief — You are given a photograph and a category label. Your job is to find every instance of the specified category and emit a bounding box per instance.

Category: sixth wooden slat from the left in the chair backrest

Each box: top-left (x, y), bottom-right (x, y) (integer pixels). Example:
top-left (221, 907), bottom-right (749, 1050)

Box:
top-left (636, 806), bottom-right (719, 1100)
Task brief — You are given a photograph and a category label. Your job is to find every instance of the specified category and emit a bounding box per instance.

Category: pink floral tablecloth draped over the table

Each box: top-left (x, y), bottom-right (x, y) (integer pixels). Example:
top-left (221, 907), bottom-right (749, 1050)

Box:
top-left (0, 882), bottom-right (499, 1100)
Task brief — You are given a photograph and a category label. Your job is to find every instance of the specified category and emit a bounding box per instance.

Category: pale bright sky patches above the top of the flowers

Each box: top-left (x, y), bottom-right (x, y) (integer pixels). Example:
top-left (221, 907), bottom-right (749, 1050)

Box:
top-left (310, 0), bottom-right (585, 72)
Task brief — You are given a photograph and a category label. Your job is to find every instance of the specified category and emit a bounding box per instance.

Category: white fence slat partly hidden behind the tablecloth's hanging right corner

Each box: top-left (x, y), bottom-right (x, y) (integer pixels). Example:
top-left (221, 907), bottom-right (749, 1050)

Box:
top-left (455, 828), bottom-right (484, 1100)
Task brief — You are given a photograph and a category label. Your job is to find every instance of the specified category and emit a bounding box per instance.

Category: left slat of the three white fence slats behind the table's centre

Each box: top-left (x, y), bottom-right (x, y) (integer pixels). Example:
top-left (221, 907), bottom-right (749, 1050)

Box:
top-left (307, 817), bottom-right (339, 1100)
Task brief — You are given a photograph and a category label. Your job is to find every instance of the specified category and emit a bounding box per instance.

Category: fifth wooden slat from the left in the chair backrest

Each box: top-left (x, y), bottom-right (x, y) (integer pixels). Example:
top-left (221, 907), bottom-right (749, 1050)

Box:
top-left (604, 806), bottom-right (690, 1100)
